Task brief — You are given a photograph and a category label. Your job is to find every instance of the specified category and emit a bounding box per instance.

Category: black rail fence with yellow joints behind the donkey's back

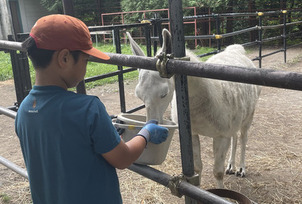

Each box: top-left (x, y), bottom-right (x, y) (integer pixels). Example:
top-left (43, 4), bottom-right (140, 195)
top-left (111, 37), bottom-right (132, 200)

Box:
top-left (153, 9), bottom-right (302, 67)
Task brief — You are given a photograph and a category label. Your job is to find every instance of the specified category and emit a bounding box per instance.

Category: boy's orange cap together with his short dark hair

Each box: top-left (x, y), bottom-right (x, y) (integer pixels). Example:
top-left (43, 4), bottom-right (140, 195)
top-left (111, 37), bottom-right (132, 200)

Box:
top-left (24, 14), bottom-right (110, 68)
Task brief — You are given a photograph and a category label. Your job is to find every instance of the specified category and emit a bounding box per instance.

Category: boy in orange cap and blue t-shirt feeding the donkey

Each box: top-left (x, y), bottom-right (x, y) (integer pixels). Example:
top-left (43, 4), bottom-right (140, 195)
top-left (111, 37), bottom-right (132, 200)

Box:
top-left (16, 15), bottom-right (168, 204)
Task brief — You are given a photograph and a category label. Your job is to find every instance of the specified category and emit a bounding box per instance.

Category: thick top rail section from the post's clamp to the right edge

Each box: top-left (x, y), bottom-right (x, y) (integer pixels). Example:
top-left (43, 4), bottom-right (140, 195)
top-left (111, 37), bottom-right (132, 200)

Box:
top-left (167, 60), bottom-right (302, 90)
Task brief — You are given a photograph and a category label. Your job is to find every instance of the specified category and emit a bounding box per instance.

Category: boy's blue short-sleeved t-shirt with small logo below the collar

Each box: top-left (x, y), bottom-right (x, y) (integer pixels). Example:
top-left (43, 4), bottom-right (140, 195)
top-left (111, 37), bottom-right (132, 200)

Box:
top-left (16, 86), bottom-right (122, 204)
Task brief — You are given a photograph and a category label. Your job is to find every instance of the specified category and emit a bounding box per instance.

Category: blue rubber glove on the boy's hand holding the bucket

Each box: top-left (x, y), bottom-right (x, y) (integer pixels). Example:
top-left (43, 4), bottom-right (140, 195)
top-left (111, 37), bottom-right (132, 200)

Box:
top-left (137, 120), bottom-right (169, 144)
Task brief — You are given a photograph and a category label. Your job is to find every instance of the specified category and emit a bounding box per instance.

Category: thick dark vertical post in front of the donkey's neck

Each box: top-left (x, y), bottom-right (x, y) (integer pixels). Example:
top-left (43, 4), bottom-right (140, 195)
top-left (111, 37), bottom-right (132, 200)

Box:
top-left (169, 0), bottom-right (197, 204)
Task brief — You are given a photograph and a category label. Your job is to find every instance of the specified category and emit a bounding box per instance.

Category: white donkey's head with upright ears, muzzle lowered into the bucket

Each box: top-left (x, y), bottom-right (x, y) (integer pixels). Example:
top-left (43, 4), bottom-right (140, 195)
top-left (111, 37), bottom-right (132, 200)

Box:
top-left (127, 29), bottom-right (174, 123)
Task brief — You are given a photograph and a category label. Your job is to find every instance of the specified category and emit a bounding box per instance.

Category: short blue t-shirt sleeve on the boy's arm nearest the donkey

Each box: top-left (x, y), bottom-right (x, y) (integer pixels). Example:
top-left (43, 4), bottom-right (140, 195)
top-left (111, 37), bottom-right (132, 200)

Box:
top-left (88, 97), bottom-right (121, 154)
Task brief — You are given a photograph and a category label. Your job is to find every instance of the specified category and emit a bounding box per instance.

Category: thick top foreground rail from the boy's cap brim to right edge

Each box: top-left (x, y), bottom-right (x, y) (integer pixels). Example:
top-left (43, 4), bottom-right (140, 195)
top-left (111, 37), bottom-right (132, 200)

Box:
top-left (92, 53), bottom-right (302, 90)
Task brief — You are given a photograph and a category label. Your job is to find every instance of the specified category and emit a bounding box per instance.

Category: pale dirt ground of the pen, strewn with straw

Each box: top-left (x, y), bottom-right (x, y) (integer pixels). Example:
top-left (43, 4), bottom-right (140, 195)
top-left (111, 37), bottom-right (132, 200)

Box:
top-left (0, 47), bottom-right (302, 204)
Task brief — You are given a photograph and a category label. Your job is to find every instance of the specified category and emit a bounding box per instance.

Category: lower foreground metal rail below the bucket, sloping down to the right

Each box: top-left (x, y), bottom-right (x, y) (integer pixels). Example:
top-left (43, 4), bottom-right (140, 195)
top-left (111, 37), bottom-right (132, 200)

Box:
top-left (129, 164), bottom-right (231, 204)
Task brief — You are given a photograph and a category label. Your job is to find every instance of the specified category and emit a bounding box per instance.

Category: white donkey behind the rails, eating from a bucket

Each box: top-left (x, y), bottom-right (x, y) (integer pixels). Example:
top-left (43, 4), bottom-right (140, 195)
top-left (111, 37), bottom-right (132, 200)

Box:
top-left (127, 29), bottom-right (260, 188)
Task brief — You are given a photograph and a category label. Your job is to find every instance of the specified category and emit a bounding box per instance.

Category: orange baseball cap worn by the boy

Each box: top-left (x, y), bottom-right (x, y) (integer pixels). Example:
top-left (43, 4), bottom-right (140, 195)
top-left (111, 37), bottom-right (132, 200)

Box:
top-left (30, 14), bottom-right (110, 60)
